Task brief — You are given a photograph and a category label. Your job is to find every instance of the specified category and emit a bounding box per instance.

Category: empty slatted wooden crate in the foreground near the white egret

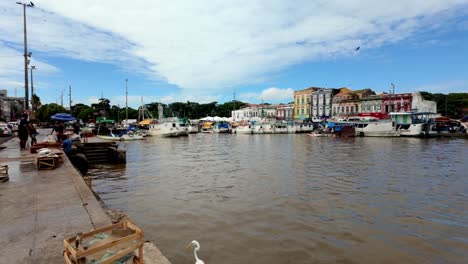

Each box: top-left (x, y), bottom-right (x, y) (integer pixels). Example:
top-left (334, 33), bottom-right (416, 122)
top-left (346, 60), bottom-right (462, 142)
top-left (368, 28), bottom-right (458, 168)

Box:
top-left (63, 221), bottom-right (143, 264)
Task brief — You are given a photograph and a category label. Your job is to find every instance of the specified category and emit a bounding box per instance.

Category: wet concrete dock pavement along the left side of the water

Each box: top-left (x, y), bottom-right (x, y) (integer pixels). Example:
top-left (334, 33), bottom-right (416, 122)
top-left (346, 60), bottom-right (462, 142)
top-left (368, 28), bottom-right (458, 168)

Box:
top-left (0, 134), bottom-right (169, 264)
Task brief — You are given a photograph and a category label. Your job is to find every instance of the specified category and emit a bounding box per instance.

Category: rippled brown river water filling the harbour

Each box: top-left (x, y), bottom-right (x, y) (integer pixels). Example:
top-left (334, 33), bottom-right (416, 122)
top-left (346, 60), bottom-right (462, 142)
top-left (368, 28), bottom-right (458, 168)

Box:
top-left (90, 134), bottom-right (468, 264)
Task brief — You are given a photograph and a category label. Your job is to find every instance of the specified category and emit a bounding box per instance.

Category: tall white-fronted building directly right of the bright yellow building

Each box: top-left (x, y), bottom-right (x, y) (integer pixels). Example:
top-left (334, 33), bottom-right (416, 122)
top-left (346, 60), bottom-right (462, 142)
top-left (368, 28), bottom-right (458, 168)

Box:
top-left (311, 88), bottom-right (340, 119)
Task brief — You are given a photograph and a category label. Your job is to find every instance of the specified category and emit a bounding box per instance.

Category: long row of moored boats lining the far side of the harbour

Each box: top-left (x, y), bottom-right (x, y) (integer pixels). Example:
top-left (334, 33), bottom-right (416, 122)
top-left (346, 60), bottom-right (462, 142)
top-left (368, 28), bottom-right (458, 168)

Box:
top-left (94, 112), bottom-right (438, 140)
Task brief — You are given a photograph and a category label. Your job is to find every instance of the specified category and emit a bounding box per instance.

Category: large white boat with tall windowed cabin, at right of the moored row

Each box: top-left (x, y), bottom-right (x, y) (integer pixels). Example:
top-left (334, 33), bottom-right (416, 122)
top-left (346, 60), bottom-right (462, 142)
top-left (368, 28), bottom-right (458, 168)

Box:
top-left (390, 112), bottom-right (438, 137)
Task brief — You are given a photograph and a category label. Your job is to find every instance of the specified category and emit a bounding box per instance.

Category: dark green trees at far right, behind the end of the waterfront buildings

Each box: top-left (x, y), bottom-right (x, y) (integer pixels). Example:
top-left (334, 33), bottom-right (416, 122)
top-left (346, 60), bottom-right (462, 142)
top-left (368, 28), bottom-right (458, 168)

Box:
top-left (421, 92), bottom-right (468, 118)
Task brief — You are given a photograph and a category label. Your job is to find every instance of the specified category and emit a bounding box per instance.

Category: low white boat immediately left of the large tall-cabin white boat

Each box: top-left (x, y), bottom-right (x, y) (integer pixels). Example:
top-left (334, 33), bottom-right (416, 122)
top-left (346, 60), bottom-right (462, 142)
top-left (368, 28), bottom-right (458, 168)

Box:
top-left (350, 120), bottom-right (400, 137)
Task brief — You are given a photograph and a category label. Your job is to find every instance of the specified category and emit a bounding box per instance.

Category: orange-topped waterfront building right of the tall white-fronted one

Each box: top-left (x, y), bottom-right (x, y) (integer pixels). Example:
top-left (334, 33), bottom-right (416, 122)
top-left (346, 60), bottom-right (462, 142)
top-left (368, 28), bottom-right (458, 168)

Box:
top-left (332, 87), bottom-right (375, 117)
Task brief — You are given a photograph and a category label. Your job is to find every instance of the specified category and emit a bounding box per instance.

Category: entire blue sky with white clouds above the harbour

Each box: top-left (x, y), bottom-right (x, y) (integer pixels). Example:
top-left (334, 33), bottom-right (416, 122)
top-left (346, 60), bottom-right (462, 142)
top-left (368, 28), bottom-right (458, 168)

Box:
top-left (0, 0), bottom-right (468, 108)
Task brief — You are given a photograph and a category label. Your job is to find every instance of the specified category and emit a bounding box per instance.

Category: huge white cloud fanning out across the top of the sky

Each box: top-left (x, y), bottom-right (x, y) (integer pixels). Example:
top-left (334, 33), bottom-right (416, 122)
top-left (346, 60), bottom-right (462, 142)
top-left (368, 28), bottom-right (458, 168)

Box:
top-left (0, 0), bottom-right (467, 94)
